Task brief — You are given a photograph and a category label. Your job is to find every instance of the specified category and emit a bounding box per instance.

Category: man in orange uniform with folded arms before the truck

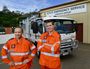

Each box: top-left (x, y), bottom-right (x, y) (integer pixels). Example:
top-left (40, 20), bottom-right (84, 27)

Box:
top-left (38, 21), bottom-right (61, 69)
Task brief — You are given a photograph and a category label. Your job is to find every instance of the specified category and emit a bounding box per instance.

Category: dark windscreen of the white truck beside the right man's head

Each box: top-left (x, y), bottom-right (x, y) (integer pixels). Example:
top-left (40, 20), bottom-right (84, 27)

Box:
top-left (53, 20), bottom-right (75, 33)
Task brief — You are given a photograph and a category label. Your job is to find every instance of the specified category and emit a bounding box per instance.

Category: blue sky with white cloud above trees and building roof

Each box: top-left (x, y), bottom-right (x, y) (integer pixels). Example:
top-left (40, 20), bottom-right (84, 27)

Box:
top-left (0, 0), bottom-right (73, 13)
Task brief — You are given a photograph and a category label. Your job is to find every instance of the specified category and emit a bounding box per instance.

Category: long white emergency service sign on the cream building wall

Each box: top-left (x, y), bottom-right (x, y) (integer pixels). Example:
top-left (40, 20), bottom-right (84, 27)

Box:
top-left (42, 4), bottom-right (87, 16)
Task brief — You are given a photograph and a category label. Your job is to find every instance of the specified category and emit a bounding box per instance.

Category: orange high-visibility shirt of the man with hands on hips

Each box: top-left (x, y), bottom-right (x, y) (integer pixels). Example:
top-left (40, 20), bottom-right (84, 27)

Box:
top-left (1, 37), bottom-right (36, 66)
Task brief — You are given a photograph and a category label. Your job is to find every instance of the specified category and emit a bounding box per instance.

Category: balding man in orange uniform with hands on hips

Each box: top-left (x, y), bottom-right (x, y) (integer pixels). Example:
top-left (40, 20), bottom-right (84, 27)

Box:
top-left (1, 27), bottom-right (36, 69)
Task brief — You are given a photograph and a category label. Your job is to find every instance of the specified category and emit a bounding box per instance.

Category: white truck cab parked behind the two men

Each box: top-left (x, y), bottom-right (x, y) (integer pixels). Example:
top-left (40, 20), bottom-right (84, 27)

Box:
top-left (20, 17), bottom-right (78, 56)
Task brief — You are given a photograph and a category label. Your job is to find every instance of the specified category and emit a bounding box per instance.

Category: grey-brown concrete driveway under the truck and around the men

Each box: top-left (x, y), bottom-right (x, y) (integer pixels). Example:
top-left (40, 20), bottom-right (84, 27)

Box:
top-left (0, 43), bottom-right (90, 69)
